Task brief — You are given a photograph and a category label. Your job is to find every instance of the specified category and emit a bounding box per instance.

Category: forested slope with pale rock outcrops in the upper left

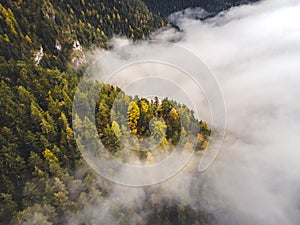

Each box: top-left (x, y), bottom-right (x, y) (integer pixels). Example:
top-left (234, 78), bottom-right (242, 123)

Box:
top-left (0, 0), bottom-right (166, 70)
